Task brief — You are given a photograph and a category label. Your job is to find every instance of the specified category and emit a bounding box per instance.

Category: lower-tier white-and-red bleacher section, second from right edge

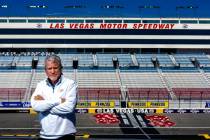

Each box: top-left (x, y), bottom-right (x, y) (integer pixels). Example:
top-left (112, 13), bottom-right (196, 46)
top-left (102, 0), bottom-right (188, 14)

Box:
top-left (120, 72), bottom-right (169, 100)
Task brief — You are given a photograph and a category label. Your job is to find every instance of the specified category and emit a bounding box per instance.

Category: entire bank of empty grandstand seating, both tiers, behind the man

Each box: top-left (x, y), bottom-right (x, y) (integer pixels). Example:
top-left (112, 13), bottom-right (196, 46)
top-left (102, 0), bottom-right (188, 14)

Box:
top-left (0, 53), bottom-right (210, 106)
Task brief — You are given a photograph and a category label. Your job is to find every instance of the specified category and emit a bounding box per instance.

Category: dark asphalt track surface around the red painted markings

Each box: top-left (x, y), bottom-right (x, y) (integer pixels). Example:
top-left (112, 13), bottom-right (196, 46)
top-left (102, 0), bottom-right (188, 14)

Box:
top-left (0, 113), bottom-right (210, 139)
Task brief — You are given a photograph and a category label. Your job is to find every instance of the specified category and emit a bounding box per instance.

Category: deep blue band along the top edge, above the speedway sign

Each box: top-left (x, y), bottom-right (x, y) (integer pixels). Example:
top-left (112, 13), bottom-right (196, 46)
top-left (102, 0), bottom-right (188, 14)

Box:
top-left (0, 0), bottom-right (210, 18)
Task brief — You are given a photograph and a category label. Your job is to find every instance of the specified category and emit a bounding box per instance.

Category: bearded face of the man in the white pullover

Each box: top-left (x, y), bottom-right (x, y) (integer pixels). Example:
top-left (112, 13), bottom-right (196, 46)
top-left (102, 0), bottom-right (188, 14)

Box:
top-left (45, 61), bottom-right (61, 83)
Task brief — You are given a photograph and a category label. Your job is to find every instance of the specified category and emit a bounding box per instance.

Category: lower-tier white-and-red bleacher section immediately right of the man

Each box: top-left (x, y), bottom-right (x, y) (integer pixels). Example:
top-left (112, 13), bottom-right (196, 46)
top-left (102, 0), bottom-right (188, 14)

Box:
top-left (77, 72), bottom-right (121, 101)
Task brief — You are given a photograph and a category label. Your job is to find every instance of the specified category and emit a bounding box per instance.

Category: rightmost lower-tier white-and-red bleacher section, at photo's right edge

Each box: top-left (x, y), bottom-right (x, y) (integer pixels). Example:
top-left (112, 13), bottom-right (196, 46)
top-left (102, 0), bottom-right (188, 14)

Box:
top-left (164, 72), bottom-right (210, 99)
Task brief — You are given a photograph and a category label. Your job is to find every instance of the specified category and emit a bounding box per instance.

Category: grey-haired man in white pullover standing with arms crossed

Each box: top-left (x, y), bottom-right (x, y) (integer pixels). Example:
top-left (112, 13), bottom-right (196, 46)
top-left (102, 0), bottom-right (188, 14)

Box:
top-left (31, 55), bottom-right (77, 140)
